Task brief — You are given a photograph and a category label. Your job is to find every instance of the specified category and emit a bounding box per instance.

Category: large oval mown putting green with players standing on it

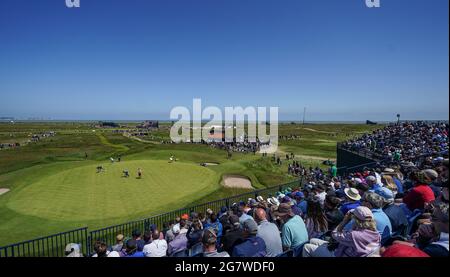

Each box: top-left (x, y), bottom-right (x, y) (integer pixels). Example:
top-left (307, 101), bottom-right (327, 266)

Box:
top-left (7, 160), bottom-right (218, 221)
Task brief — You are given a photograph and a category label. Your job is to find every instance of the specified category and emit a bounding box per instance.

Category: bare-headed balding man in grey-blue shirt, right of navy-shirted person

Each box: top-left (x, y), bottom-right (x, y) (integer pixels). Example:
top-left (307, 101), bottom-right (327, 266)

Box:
top-left (255, 208), bottom-right (283, 257)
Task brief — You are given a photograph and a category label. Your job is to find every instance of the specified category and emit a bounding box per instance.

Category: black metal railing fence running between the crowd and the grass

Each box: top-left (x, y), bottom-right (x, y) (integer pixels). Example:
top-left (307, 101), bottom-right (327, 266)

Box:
top-left (0, 180), bottom-right (302, 257)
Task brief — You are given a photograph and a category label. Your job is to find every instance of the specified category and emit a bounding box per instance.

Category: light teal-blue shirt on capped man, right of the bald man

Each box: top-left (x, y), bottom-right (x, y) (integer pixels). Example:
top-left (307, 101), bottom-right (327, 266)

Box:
top-left (281, 215), bottom-right (309, 249)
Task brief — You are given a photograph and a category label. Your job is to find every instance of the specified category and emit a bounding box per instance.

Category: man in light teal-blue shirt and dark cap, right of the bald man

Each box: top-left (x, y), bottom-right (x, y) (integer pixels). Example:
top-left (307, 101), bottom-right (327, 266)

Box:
top-left (274, 203), bottom-right (308, 251)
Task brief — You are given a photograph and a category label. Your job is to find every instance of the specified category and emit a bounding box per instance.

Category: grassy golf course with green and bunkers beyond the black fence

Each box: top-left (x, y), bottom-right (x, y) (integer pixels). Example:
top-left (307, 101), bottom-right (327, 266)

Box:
top-left (0, 122), bottom-right (380, 245)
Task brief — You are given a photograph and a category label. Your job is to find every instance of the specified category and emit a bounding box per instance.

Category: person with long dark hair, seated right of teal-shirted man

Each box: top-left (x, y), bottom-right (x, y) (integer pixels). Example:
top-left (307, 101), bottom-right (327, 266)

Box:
top-left (305, 196), bottom-right (328, 239)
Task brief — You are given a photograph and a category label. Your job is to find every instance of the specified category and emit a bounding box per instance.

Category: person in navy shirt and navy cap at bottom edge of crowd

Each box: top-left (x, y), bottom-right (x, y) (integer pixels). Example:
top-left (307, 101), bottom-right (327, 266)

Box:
top-left (232, 219), bottom-right (266, 257)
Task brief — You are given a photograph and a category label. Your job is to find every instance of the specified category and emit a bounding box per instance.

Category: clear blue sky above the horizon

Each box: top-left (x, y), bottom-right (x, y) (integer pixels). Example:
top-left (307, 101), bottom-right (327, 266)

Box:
top-left (0, 0), bottom-right (449, 121)
